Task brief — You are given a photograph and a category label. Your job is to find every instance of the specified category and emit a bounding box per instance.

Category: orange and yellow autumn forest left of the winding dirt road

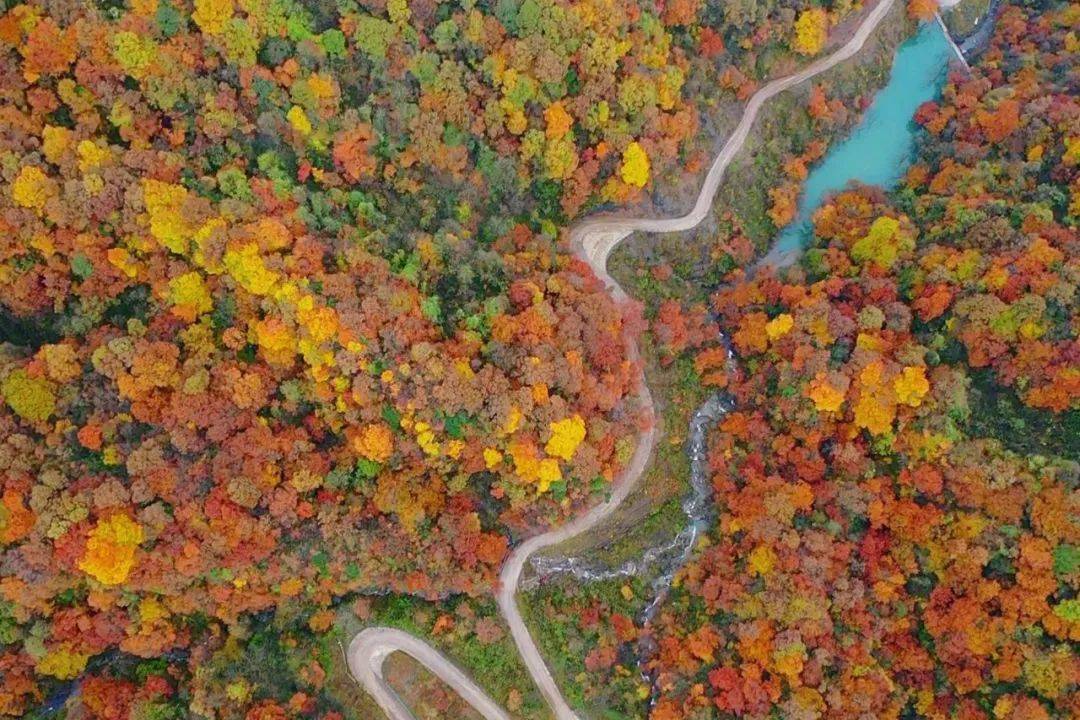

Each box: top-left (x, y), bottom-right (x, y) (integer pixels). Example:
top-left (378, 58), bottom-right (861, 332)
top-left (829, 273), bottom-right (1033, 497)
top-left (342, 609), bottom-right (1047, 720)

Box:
top-left (0, 0), bottom-right (876, 719)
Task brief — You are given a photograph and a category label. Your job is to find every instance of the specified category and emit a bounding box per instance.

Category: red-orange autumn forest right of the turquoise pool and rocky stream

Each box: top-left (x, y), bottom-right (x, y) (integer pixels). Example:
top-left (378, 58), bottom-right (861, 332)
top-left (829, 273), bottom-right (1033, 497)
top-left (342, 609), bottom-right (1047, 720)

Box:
top-left (635, 4), bottom-right (1080, 720)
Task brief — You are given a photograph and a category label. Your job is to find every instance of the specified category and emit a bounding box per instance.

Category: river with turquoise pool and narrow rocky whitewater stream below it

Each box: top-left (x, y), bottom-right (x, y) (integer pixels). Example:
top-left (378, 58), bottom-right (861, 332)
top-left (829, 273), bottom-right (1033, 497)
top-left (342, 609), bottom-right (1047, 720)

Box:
top-left (531, 23), bottom-right (954, 621)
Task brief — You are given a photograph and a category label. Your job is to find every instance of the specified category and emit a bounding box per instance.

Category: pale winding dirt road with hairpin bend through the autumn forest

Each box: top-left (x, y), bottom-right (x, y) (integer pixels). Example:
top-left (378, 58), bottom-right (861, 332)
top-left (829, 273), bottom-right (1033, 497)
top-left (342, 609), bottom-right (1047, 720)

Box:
top-left (348, 0), bottom-right (894, 720)
